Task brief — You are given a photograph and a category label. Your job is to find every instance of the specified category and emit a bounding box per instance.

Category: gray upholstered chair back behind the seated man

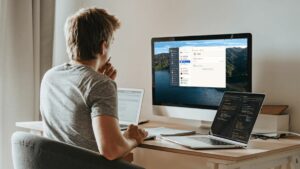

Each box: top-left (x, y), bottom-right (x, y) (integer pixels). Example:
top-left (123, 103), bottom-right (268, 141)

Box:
top-left (12, 132), bottom-right (142, 169)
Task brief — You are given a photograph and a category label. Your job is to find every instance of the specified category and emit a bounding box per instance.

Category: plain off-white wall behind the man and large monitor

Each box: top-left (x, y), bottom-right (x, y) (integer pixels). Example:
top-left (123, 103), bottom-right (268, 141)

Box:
top-left (54, 0), bottom-right (300, 132)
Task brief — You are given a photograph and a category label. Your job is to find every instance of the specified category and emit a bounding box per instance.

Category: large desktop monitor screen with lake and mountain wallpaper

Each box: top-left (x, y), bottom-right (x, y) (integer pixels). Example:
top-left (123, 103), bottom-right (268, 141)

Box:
top-left (152, 33), bottom-right (252, 109)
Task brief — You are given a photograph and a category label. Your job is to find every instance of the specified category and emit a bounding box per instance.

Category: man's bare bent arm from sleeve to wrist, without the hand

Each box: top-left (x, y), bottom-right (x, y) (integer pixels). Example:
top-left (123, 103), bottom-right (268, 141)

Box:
top-left (92, 115), bottom-right (138, 160)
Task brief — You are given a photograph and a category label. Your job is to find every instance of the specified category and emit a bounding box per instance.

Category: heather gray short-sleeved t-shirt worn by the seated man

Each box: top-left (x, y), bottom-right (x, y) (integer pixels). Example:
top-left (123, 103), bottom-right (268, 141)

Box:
top-left (40, 63), bottom-right (118, 152)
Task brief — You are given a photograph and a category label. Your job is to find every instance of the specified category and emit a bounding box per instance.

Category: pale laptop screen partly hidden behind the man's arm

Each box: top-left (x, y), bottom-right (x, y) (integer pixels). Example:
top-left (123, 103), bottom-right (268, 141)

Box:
top-left (118, 88), bottom-right (143, 124)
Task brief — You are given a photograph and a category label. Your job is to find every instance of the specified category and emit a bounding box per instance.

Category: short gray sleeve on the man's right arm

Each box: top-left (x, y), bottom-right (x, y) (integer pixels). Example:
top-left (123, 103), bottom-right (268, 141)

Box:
top-left (88, 79), bottom-right (118, 118)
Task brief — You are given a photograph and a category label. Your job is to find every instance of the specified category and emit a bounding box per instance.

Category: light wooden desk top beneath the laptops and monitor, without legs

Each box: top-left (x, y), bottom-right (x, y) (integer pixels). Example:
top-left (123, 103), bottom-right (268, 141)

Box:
top-left (16, 121), bottom-right (300, 161)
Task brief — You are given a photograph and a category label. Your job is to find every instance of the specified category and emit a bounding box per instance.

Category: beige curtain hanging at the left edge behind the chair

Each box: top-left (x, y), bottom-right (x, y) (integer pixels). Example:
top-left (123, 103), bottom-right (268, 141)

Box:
top-left (0, 0), bottom-right (54, 169)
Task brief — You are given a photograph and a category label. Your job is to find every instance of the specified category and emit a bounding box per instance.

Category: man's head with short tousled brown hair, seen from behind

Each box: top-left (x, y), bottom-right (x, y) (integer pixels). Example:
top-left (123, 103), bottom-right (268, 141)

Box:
top-left (65, 8), bottom-right (120, 61)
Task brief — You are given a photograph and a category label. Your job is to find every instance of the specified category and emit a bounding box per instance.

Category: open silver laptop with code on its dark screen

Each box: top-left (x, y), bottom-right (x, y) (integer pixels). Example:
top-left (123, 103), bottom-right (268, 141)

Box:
top-left (162, 92), bottom-right (265, 149)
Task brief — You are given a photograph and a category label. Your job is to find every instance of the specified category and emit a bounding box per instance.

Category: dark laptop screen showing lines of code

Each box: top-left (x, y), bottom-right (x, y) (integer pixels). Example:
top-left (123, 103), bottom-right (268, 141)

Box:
top-left (211, 92), bottom-right (265, 144)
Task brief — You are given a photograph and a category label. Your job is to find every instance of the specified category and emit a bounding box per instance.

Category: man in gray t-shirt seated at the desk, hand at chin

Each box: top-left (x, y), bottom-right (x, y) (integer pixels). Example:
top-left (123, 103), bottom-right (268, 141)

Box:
top-left (40, 8), bottom-right (147, 160)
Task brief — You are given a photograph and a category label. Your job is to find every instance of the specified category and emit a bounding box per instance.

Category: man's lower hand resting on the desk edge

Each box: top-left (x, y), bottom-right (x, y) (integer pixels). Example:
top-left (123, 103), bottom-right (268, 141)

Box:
top-left (124, 124), bottom-right (148, 145)
